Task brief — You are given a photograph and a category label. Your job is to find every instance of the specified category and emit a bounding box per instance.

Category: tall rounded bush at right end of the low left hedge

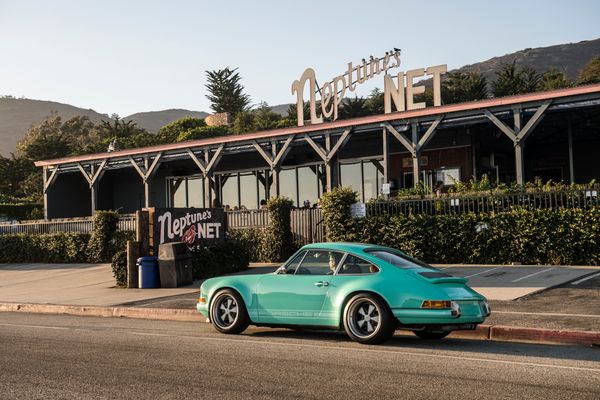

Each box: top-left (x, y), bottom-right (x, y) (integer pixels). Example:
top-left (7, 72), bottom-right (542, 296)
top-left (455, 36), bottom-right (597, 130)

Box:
top-left (87, 211), bottom-right (119, 262)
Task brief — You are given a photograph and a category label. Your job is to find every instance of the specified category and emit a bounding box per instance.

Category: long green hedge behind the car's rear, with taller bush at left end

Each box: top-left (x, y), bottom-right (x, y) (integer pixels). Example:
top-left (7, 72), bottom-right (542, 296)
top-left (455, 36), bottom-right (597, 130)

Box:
top-left (322, 188), bottom-right (600, 265)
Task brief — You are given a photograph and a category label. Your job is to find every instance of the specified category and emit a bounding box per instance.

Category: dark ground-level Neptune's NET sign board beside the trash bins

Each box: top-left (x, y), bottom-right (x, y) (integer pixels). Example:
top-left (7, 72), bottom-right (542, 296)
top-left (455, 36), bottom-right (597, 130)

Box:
top-left (154, 208), bottom-right (227, 248)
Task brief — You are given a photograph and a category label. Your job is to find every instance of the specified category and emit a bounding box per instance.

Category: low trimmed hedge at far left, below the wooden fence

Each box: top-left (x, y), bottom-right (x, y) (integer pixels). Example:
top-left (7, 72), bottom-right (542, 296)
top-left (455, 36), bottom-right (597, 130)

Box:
top-left (0, 233), bottom-right (90, 263)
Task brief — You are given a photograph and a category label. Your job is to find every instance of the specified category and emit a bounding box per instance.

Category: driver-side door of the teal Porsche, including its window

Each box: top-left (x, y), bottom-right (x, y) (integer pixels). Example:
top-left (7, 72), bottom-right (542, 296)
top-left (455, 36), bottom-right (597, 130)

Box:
top-left (256, 250), bottom-right (344, 325)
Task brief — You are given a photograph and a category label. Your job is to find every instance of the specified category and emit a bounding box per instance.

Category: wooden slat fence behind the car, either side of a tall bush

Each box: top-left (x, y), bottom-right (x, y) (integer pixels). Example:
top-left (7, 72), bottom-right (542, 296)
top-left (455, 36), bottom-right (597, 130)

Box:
top-left (227, 208), bottom-right (325, 244)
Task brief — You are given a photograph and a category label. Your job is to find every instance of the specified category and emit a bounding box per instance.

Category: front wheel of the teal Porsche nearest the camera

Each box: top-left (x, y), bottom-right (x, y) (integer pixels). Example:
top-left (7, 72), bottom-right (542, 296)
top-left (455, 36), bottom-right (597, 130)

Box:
top-left (210, 289), bottom-right (250, 334)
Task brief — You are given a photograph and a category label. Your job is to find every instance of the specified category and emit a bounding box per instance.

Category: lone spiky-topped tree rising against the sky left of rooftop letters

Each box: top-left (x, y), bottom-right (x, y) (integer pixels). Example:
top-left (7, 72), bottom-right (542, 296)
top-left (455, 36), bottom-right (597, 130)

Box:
top-left (206, 67), bottom-right (250, 119)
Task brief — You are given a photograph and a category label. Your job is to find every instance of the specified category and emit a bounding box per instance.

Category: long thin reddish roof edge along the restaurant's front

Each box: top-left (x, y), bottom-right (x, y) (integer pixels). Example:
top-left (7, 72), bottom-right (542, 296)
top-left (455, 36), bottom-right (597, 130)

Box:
top-left (35, 84), bottom-right (600, 167)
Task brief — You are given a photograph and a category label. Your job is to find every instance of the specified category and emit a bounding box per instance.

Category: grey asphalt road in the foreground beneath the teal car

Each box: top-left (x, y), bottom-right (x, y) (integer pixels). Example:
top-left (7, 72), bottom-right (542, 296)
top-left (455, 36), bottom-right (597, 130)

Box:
top-left (0, 313), bottom-right (600, 400)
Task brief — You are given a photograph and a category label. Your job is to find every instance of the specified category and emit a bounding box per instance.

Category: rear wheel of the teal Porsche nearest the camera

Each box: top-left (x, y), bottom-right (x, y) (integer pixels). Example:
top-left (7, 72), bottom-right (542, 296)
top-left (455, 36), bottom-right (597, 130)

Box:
top-left (343, 293), bottom-right (396, 344)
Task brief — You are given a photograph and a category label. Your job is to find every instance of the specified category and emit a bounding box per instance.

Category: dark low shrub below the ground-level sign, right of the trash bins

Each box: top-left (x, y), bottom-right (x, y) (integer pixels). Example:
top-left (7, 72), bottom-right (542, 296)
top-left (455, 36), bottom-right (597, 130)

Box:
top-left (192, 240), bottom-right (250, 279)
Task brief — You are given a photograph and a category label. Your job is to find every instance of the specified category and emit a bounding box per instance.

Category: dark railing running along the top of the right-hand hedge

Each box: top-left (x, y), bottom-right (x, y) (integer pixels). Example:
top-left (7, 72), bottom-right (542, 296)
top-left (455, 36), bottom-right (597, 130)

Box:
top-left (366, 188), bottom-right (600, 215)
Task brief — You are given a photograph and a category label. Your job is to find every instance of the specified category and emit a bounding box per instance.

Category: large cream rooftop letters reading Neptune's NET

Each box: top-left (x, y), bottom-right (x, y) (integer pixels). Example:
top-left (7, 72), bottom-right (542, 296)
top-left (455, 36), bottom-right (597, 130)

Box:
top-left (292, 49), bottom-right (447, 126)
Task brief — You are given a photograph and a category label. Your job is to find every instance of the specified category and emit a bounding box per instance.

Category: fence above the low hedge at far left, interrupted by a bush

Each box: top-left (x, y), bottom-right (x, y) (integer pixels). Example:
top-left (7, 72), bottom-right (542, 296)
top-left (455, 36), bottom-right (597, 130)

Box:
top-left (0, 214), bottom-right (136, 235)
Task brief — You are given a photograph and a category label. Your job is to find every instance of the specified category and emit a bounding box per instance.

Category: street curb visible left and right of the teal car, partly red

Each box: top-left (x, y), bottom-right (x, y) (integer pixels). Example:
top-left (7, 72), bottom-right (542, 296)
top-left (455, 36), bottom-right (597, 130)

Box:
top-left (0, 303), bottom-right (600, 346)
